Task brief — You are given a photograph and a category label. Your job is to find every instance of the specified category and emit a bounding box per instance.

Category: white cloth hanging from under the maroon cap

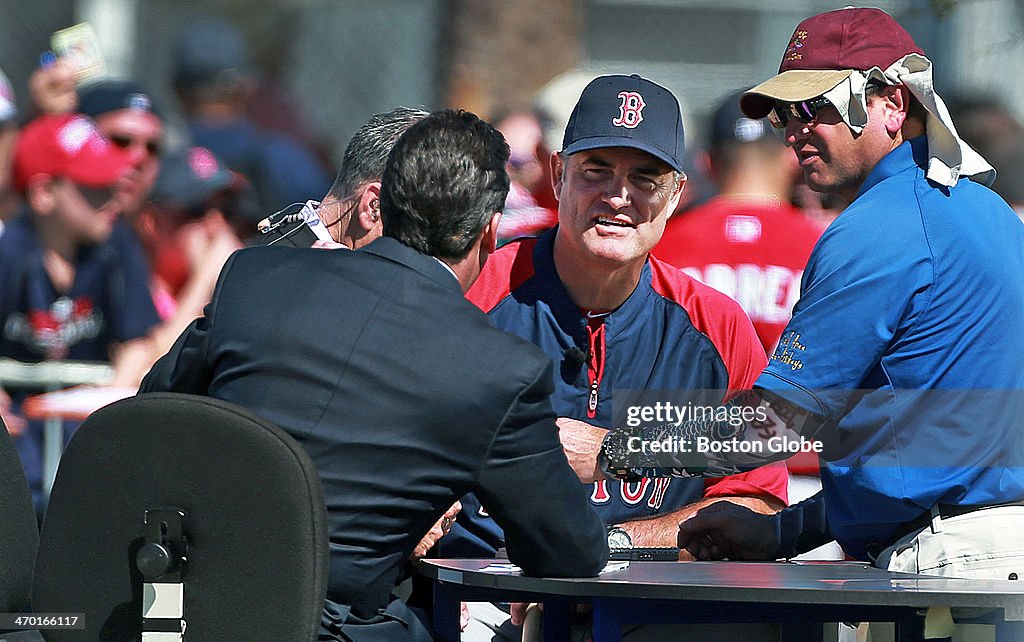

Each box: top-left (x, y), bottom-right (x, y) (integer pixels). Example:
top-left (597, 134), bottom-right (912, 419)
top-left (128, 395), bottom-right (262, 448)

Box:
top-left (824, 53), bottom-right (995, 187)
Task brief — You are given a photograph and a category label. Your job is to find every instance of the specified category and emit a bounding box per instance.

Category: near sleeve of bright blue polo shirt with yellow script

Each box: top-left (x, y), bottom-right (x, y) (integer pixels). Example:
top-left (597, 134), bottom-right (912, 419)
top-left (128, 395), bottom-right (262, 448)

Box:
top-left (756, 199), bottom-right (932, 418)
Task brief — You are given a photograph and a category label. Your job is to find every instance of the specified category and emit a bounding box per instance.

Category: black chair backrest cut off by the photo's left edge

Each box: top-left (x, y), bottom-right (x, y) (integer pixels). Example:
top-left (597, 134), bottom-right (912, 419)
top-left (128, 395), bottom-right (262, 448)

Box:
top-left (0, 420), bottom-right (39, 613)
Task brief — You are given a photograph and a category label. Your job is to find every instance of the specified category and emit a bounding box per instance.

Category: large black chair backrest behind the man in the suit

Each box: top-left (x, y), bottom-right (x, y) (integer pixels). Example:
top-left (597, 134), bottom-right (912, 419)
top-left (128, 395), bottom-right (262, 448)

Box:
top-left (32, 393), bottom-right (328, 642)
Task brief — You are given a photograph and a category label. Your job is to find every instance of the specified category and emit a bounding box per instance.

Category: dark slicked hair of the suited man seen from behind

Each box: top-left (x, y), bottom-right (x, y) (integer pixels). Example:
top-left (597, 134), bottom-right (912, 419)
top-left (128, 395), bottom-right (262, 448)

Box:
top-left (381, 110), bottom-right (509, 259)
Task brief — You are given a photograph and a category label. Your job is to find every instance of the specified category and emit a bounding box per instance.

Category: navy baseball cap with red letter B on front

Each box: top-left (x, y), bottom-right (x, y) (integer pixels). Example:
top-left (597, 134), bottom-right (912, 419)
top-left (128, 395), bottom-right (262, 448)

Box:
top-left (562, 74), bottom-right (683, 172)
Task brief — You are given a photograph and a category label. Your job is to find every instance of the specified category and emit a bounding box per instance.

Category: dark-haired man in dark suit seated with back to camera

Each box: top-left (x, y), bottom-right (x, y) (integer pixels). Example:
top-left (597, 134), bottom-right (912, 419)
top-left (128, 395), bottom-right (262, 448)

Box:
top-left (141, 111), bottom-right (607, 641)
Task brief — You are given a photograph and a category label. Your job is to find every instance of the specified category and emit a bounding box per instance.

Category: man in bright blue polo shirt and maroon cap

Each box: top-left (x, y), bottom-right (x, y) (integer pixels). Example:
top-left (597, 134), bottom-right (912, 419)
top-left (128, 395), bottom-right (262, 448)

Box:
top-left (566, 8), bottom-right (1024, 593)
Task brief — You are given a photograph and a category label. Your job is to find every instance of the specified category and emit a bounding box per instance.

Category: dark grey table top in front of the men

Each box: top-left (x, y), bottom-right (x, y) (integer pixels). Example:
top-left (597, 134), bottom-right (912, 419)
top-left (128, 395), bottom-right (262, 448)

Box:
top-left (420, 559), bottom-right (1024, 620)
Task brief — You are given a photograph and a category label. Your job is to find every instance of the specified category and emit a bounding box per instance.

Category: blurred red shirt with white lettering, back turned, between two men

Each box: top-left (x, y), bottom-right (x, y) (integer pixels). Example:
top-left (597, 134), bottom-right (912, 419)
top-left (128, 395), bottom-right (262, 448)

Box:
top-left (653, 196), bottom-right (823, 354)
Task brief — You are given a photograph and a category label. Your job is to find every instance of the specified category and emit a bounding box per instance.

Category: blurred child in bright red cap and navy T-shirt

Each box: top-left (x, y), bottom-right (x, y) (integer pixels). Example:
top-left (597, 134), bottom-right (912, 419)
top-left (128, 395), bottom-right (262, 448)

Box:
top-left (0, 115), bottom-right (159, 514)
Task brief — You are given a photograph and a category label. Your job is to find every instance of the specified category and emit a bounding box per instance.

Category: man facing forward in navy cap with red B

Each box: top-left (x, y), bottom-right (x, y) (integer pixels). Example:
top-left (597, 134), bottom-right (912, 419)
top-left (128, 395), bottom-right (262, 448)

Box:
top-left (452, 75), bottom-right (786, 640)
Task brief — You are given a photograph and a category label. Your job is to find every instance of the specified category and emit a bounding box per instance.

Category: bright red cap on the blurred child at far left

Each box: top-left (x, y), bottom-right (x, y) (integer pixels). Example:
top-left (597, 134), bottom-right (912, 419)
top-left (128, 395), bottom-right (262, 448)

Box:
top-left (14, 114), bottom-right (131, 190)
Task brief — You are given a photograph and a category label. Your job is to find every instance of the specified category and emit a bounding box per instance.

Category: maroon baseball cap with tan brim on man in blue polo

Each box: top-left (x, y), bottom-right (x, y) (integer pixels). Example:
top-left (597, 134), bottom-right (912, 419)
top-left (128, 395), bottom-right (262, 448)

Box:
top-left (740, 7), bottom-right (924, 118)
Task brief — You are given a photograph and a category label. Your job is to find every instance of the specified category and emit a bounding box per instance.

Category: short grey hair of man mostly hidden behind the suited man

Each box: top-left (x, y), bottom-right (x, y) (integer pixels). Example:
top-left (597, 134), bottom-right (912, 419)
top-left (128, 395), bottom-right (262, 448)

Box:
top-left (330, 108), bottom-right (429, 199)
